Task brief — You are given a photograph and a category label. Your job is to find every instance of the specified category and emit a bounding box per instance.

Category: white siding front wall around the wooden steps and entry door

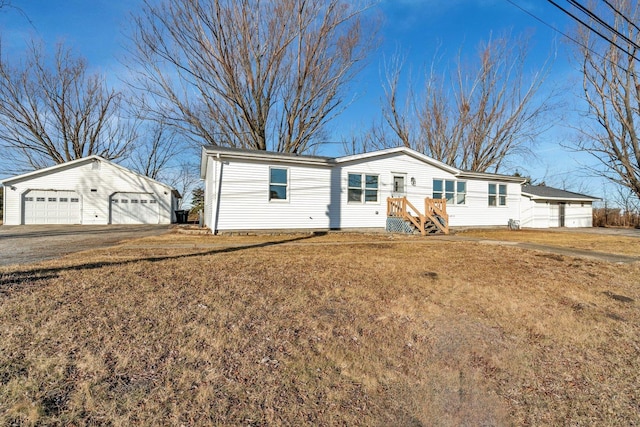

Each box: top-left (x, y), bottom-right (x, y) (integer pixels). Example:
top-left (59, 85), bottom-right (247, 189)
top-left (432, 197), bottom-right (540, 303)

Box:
top-left (331, 153), bottom-right (521, 228)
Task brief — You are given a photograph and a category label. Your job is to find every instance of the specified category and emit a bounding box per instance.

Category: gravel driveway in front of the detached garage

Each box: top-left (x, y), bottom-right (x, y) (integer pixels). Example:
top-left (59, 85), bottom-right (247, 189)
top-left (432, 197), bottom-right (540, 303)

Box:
top-left (0, 225), bottom-right (170, 266)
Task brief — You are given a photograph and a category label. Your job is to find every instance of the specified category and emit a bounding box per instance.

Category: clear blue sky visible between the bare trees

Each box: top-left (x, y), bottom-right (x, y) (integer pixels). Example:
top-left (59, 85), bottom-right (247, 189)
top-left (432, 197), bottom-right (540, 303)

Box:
top-left (0, 0), bottom-right (603, 196)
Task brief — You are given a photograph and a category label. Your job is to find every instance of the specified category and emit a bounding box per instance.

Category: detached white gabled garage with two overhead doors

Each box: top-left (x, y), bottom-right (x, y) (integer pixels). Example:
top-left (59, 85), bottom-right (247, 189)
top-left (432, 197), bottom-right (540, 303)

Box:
top-left (2, 156), bottom-right (180, 225)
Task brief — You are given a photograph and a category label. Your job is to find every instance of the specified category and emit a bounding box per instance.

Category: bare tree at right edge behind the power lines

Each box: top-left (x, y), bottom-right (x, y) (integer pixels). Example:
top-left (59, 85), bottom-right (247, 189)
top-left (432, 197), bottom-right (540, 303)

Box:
top-left (576, 0), bottom-right (640, 197)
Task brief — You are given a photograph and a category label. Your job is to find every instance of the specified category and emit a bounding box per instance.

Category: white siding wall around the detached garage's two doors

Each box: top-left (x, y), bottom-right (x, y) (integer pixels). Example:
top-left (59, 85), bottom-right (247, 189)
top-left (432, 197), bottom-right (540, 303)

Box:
top-left (5, 161), bottom-right (175, 225)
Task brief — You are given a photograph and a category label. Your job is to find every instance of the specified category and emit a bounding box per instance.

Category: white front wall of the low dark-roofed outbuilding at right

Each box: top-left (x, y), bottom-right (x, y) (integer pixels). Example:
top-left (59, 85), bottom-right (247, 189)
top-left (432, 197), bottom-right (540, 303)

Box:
top-left (520, 197), bottom-right (593, 228)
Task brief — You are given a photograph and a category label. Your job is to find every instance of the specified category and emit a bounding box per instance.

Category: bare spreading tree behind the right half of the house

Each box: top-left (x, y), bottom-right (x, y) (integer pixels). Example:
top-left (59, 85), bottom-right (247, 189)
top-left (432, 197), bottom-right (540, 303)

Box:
top-left (383, 36), bottom-right (557, 172)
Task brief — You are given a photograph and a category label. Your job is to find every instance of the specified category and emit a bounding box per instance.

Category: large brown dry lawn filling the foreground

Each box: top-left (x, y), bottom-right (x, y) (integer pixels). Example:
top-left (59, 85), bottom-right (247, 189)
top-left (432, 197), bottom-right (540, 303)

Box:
top-left (0, 235), bottom-right (640, 426)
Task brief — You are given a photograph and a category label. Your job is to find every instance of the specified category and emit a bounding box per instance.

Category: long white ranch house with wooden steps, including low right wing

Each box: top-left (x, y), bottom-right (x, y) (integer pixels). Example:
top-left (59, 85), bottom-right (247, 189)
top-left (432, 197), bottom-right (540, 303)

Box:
top-left (200, 146), bottom-right (597, 233)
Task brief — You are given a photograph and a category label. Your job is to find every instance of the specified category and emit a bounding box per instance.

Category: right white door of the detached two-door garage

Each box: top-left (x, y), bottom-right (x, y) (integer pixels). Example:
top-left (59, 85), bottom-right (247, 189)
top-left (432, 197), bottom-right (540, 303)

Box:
top-left (110, 193), bottom-right (160, 224)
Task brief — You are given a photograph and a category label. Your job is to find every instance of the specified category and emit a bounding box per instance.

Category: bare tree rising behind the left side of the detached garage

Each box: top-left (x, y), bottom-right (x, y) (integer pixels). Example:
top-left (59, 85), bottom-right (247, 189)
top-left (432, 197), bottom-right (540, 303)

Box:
top-left (0, 43), bottom-right (136, 170)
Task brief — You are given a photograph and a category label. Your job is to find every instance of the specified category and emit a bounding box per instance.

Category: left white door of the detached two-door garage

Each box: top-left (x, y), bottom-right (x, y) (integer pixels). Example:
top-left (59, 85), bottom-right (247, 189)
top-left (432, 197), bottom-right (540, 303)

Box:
top-left (22, 190), bottom-right (81, 224)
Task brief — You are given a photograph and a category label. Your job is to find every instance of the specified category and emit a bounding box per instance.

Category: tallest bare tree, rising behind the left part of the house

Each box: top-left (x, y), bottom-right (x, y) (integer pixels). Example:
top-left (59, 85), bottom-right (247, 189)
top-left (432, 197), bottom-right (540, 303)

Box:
top-left (127, 0), bottom-right (371, 153)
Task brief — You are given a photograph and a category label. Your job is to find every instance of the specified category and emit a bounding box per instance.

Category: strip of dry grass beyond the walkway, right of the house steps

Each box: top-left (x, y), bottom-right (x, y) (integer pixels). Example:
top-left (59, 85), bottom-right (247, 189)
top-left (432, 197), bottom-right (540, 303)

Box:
top-left (459, 229), bottom-right (640, 256)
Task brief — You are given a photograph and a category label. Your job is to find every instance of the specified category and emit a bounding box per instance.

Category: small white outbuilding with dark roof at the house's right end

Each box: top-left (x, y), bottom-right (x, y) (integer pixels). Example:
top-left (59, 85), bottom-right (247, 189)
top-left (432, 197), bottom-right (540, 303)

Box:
top-left (520, 185), bottom-right (600, 228)
